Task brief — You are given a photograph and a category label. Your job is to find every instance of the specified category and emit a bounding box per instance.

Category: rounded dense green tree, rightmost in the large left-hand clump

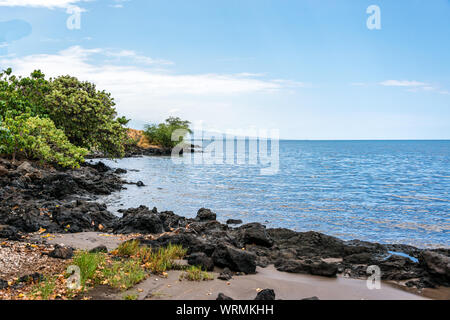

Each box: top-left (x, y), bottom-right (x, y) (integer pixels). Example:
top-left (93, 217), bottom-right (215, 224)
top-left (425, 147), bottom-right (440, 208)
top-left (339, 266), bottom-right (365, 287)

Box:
top-left (45, 76), bottom-right (128, 157)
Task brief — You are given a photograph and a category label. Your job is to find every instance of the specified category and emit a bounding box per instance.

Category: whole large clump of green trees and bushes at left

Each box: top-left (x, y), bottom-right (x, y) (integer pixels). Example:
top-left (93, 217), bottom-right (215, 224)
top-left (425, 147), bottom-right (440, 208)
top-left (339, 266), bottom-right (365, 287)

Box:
top-left (0, 69), bottom-right (129, 167)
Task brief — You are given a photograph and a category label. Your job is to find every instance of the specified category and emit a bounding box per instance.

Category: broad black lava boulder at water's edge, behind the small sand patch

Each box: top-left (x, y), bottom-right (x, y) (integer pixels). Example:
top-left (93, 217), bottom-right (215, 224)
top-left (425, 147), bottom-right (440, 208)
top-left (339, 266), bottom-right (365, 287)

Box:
top-left (114, 206), bottom-right (164, 234)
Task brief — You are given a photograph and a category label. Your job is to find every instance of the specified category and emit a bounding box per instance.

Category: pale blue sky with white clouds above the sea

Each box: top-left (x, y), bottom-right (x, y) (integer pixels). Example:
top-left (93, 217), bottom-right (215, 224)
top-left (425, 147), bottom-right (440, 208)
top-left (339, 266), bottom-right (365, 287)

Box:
top-left (0, 0), bottom-right (450, 140)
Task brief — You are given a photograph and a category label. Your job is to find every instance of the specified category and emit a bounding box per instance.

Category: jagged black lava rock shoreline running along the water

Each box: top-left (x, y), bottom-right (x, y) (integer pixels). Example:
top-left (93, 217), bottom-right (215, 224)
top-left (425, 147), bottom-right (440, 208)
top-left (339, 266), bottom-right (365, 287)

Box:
top-left (0, 159), bottom-right (450, 298)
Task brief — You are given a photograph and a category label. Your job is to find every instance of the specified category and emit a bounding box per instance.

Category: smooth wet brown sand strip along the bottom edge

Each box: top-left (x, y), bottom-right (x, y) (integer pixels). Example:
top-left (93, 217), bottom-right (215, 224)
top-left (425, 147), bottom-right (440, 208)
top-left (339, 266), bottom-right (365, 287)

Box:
top-left (116, 266), bottom-right (427, 300)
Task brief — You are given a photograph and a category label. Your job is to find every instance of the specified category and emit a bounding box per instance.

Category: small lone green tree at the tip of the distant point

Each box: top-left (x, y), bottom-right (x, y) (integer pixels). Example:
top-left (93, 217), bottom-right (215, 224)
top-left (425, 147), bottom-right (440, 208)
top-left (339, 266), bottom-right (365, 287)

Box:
top-left (144, 117), bottom-right (192, 148)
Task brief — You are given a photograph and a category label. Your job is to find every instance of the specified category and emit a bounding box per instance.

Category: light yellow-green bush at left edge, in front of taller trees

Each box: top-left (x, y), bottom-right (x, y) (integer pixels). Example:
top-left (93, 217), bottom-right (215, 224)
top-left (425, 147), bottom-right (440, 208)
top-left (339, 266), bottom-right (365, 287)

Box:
top-left (0, 113), bottom-right (88, 168)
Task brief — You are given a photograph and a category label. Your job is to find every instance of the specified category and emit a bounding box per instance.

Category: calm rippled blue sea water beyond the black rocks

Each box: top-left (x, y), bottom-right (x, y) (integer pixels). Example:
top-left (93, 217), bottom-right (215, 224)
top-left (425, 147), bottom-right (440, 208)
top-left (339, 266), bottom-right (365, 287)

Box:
top-left (93, 141), bottom-right (450, 247)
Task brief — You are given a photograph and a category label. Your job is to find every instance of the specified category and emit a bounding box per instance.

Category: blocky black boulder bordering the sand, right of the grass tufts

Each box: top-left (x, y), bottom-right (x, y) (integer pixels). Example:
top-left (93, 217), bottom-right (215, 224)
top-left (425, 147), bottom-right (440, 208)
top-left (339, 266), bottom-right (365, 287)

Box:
top-left (212, 244), bottom-right (256, 274)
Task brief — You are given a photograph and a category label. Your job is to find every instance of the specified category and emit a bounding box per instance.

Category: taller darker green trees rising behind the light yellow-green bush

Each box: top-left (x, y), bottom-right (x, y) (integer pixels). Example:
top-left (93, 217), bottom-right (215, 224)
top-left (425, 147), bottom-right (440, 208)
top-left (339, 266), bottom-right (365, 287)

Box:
top-left (0, 68), bottom-right (129, 158)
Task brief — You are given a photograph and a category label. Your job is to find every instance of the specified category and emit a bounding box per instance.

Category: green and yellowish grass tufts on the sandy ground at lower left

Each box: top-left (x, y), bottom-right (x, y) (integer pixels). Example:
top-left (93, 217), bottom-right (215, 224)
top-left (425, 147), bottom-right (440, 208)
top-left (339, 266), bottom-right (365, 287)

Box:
top-left (16, 241), bottom-right (187, 300)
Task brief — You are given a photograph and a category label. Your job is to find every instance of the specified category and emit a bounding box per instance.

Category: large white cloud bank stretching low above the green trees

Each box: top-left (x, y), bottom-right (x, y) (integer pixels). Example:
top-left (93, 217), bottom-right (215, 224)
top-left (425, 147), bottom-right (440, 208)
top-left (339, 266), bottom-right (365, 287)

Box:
top-left (0, 46), bottom-right (304, 128)
